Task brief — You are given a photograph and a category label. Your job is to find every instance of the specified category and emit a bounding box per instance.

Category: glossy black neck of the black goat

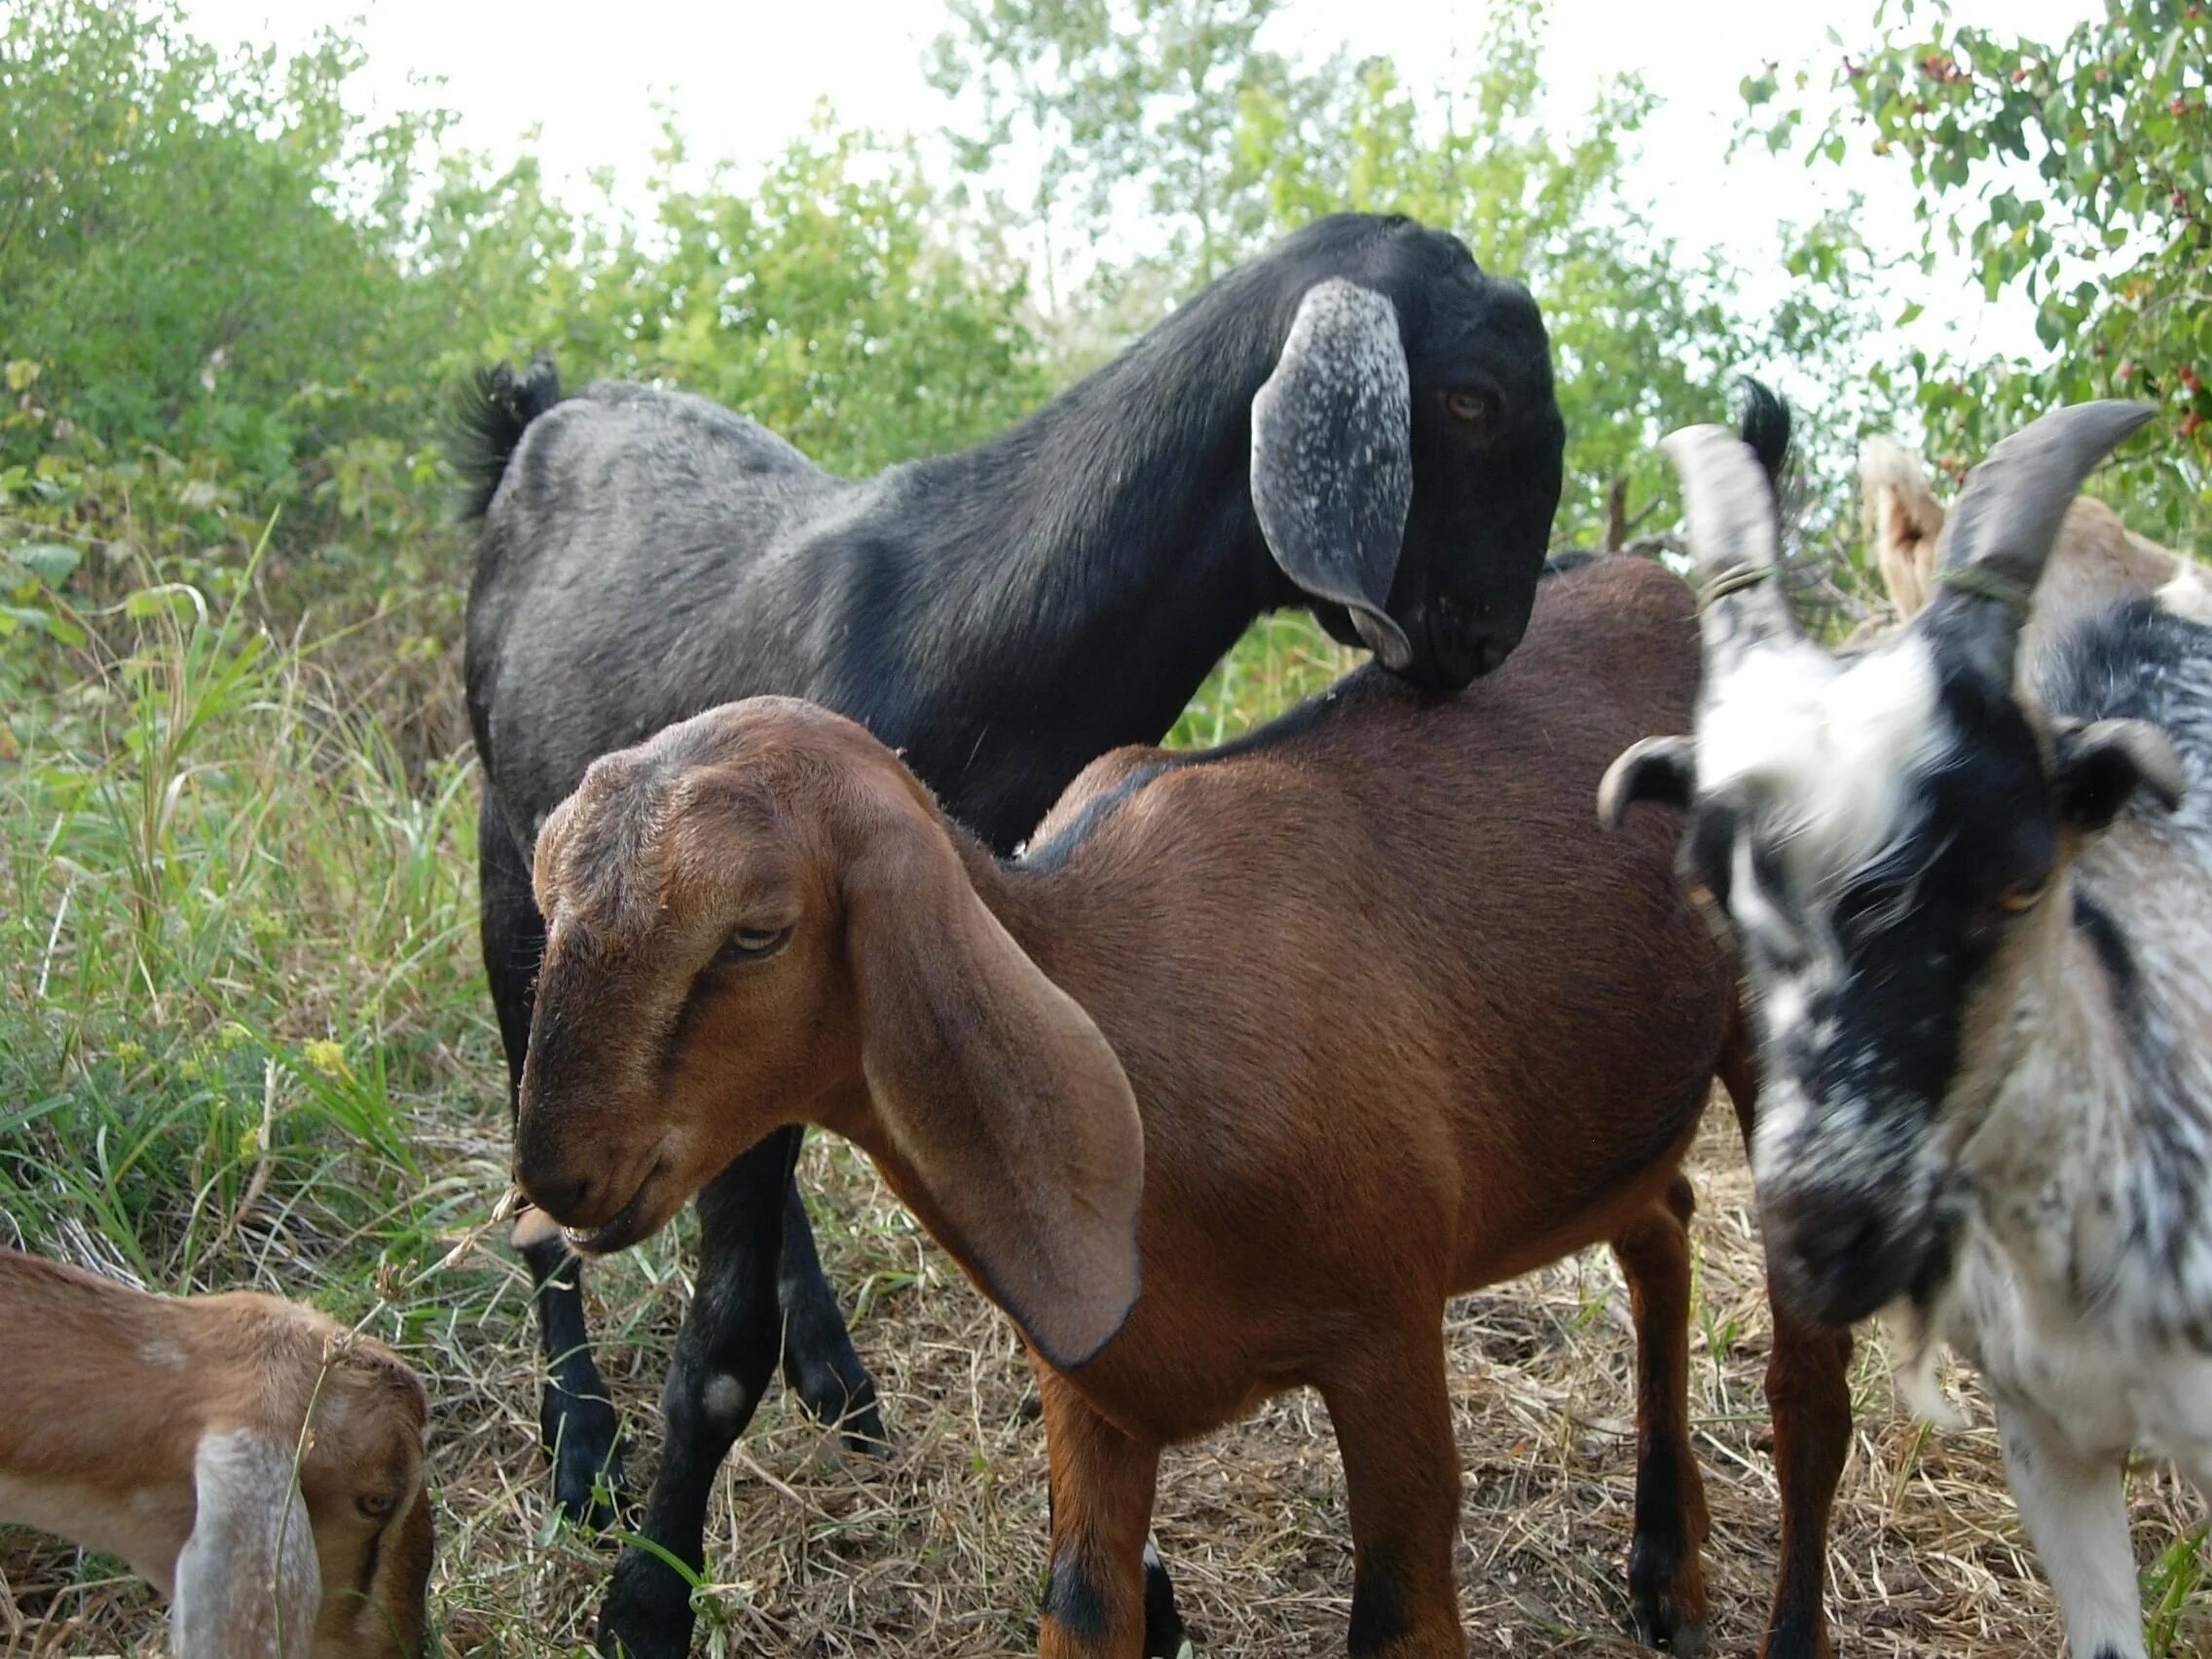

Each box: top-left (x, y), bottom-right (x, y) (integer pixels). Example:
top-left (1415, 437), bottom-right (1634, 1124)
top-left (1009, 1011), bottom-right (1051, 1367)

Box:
top-left (880, 261), bottom-right (1299, 752)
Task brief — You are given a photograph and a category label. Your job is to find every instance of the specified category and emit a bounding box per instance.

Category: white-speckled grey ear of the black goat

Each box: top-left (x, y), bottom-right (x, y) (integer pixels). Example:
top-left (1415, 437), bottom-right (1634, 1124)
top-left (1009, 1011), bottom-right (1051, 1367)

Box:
top-left (1252, 276), bottom-right (1414, 670)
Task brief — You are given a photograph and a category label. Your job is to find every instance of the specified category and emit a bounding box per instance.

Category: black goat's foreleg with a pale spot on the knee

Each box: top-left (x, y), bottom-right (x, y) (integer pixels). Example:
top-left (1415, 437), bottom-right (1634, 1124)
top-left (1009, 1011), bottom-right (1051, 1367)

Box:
top-left (597, 1128), bottom-right (798, 1659)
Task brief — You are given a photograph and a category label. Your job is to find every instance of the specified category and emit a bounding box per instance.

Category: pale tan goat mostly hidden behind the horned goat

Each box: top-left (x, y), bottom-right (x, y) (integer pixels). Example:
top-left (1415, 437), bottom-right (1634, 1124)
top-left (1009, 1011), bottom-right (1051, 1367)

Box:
top-left (1858, 438), bottom-right (2212, 661)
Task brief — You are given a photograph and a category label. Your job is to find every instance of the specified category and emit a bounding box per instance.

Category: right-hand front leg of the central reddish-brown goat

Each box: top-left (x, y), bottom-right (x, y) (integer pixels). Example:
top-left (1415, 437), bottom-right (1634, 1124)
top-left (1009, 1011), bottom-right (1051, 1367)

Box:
top-left (1320, 1336), bottom-right (1466, 1659)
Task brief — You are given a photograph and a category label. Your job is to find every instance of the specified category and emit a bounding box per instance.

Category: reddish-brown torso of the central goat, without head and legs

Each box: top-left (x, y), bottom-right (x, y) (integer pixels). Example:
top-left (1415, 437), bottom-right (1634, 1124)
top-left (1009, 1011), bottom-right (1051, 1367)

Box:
top-left (1017, 560), bottom-right (1734, 1429)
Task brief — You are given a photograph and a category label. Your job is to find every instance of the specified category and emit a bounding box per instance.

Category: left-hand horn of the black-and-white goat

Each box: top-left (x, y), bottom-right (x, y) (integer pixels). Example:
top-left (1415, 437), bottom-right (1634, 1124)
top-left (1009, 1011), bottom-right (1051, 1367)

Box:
top-left (1659, 426), bottom-right (1796, 670)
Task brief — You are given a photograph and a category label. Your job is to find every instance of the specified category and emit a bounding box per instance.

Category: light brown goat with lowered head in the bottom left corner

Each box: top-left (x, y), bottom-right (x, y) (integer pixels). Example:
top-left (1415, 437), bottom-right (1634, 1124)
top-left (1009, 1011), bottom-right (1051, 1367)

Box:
top-left (0, 1250), bottom-right (431, 1659)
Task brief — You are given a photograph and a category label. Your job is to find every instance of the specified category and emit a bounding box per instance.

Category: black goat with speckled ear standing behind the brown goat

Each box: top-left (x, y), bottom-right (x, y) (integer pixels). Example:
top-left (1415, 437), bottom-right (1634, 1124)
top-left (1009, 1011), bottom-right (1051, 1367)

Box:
top-left (466, 214), bottom-right (1564, 1659)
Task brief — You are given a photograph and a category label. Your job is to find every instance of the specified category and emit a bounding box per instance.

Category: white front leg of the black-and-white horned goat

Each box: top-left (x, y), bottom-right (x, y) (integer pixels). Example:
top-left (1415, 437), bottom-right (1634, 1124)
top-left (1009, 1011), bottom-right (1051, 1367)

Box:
top-left (1998, 1405), bottom-right (2144, 1659)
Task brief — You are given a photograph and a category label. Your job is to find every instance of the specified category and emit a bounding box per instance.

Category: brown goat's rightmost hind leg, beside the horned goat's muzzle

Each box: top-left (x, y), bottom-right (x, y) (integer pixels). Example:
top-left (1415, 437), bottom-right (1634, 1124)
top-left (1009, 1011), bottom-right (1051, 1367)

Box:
top-left (1718, 1039), bottom-right (1852, 1659)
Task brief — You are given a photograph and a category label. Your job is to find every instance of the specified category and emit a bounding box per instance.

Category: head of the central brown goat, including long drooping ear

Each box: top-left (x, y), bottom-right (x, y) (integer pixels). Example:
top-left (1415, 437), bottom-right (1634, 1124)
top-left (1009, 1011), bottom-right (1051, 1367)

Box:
top-left (515, 697), bottom-right (1144, 1367)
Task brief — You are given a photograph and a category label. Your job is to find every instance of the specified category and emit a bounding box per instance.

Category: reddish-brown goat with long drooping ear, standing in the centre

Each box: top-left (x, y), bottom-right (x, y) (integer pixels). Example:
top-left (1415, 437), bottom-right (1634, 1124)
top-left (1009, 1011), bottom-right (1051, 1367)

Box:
top-left (518, 560), bottom-right (1849, 1659)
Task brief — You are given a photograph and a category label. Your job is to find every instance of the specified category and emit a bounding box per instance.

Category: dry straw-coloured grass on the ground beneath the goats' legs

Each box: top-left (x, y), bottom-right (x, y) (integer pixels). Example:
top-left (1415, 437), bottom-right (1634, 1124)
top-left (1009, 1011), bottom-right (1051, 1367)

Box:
top-left (0, 1111), bottom-right (2212, 1659)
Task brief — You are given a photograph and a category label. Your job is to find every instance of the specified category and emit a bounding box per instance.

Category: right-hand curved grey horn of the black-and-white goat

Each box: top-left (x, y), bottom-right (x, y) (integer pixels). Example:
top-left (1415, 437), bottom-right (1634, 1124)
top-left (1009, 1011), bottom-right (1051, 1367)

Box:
top-left (1927, 398), bottom-right (2153, 683)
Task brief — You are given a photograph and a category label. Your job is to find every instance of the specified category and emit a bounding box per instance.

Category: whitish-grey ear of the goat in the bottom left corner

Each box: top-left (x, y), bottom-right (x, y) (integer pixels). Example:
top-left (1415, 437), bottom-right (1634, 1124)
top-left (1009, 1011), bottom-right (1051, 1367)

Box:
top-left (168, 1429), bottom-right (323, 1659)
